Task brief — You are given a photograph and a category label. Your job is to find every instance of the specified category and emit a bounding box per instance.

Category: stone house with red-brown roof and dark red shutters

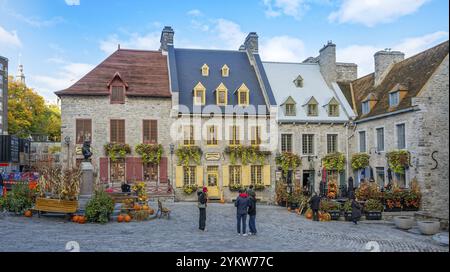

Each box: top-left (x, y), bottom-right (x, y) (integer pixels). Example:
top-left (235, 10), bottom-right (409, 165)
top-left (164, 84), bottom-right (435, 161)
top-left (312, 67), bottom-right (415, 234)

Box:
top-left (56, 48), bottom-right (172, 198)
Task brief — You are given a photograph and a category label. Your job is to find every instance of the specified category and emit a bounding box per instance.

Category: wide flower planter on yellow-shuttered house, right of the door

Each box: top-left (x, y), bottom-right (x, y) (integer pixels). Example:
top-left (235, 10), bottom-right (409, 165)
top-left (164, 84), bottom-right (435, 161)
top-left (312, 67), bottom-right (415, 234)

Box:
top-left (224, 146), bottom-right (272, 165)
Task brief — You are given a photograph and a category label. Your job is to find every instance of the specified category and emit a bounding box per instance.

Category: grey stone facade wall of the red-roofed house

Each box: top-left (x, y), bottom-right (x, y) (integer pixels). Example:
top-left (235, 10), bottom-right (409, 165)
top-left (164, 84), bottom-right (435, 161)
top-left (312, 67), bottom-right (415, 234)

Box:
top-left (61, 96), bottom-right (172, 183)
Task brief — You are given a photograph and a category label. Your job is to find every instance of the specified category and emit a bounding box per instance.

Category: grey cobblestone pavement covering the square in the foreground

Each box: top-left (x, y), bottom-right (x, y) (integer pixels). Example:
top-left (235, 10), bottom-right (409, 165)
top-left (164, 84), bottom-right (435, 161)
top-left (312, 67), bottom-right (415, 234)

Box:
top-left (0, 203), bottom-right (449, 252)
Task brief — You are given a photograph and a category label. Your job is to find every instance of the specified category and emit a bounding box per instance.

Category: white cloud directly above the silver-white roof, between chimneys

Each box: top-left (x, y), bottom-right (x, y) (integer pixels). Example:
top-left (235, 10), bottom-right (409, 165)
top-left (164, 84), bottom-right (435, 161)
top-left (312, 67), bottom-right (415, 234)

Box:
top-left (260, 36), bottom-right (305, 62)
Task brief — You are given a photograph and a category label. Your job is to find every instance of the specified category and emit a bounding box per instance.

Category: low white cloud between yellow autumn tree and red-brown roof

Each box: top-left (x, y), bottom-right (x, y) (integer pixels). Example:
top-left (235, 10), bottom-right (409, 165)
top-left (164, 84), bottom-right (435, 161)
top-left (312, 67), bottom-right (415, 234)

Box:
top-left (28, 60), bottom-right (95, 102)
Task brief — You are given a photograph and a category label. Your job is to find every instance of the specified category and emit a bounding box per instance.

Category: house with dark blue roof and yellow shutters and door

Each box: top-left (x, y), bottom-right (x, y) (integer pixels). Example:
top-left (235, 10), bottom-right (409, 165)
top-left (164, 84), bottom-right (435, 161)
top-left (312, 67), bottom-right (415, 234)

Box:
top-left (161, 27), bottom-right (277, 201)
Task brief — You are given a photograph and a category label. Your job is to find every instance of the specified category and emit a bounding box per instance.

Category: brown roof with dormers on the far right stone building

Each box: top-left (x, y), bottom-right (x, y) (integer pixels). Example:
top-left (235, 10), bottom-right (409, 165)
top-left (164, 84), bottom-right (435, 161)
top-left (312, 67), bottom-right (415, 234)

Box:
top-left (339, 41), bottom-right (449, 119)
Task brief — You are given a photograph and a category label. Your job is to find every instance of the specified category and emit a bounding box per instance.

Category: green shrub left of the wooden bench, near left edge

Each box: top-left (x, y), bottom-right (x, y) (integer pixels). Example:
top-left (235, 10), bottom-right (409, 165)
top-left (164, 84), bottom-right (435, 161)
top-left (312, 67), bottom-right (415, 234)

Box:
top-left (2, 183), bottom-right (34, 215)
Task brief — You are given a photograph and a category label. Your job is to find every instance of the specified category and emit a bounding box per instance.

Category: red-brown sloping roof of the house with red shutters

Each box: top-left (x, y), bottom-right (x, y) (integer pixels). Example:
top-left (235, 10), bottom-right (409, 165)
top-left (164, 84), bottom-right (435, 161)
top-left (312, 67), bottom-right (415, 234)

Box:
top-left (55, 49), bottom-right (171, 98)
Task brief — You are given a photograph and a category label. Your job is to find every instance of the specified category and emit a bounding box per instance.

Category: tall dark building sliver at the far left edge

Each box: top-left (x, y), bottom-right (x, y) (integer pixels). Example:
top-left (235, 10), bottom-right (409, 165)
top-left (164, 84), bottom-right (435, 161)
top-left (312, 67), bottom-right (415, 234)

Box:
top-left (0, 56), bottom-right (8, 135)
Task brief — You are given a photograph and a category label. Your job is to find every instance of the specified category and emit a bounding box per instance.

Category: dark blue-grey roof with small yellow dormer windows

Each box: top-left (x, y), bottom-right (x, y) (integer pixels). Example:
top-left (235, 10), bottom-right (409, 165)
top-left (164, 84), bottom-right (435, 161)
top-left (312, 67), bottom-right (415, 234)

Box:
top-left (168, 46), bottom-right (275, 112)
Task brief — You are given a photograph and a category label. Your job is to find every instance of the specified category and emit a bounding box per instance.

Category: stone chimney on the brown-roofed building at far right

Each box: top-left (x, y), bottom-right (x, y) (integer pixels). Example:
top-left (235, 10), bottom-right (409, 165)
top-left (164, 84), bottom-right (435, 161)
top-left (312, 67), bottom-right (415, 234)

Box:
top-left (374, 48), bottom-right (405, 85)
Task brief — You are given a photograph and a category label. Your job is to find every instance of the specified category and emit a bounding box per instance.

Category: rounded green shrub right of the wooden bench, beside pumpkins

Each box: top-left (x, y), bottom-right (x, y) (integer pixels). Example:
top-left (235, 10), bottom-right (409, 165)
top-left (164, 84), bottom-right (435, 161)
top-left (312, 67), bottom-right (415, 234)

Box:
top-left (86, 191), bottom-right (114, 224)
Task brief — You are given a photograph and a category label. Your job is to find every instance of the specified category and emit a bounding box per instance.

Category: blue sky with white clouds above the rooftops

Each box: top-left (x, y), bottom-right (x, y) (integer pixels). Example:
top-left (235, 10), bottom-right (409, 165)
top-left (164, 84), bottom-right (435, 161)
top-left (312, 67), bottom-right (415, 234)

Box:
top-left (0, 0), bottom-right (449, 103)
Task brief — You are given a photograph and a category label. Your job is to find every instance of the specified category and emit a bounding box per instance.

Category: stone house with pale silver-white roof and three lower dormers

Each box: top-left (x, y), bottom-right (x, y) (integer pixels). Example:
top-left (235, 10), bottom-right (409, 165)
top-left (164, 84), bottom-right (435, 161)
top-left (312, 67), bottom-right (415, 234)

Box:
top-left (263, 42), bottom-right (357, 196)
